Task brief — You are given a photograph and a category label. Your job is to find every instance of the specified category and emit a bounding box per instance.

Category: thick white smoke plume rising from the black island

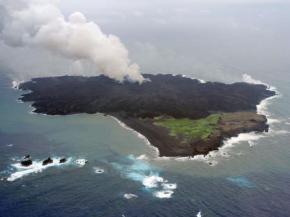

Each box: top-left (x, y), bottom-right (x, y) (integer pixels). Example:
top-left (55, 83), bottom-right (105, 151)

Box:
top-left (0, 0), bottom-right (144, 83)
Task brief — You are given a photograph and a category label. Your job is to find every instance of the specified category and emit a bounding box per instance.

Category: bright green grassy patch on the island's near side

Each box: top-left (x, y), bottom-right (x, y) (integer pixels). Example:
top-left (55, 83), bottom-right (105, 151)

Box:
top-left (154, 114), bottom-right (221, 140)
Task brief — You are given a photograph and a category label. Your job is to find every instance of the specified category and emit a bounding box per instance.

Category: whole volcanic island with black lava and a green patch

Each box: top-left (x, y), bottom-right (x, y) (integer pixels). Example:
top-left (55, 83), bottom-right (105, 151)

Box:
top-left (19, 74), bottom-right (275, 157)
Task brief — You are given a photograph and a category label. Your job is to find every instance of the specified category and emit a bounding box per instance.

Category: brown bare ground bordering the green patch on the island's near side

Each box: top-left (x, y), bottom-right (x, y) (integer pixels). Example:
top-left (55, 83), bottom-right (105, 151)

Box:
top-left (119, 112), bottom-right (268, 157)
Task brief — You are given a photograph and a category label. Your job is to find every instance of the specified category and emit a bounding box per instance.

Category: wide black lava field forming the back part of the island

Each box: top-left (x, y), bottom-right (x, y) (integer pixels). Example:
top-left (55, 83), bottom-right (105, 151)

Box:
top-left (20, 74), bottom-right (275, 119)
